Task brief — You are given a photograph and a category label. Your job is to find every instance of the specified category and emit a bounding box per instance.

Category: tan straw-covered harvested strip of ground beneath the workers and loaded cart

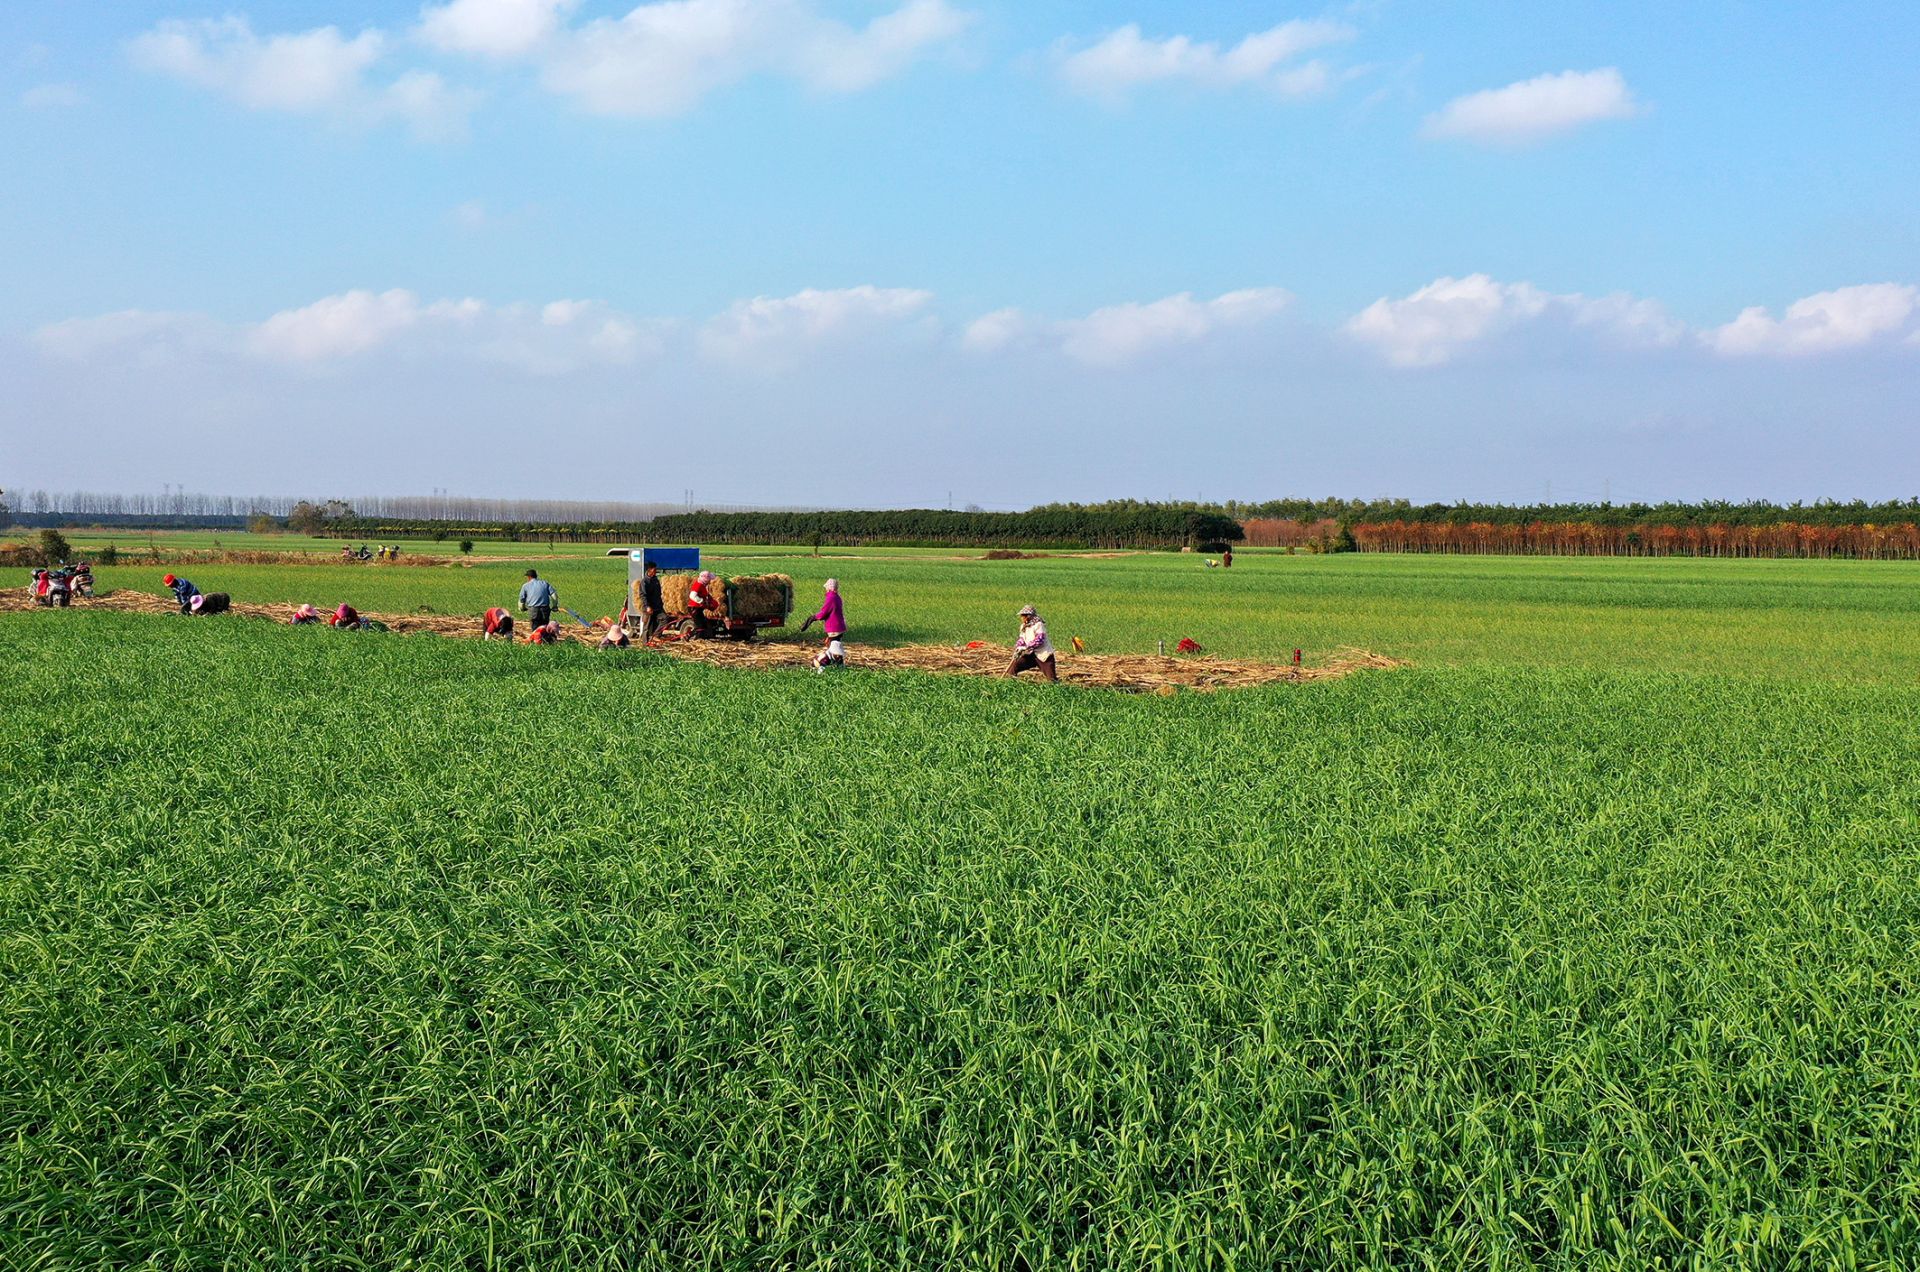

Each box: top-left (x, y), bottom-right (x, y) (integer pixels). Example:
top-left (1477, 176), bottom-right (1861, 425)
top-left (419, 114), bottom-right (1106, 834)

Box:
top-left (0, 588), bottom-right (1407, 694)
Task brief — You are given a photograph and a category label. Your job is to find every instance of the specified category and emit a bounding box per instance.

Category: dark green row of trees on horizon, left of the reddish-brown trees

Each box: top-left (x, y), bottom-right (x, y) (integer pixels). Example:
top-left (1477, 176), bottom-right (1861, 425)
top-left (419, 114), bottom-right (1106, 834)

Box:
top-left (326, 500), bottom-right (1242, 550)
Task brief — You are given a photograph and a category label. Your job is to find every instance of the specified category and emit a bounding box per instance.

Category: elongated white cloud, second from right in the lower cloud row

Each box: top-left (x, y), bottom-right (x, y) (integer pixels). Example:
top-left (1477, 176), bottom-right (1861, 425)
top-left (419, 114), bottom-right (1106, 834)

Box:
top-left (1346, 275), bottom-right (1686, 367)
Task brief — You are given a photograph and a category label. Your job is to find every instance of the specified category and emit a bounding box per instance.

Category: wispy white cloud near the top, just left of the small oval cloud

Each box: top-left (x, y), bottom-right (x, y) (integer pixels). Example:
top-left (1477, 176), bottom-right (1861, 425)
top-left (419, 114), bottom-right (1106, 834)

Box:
top-left (1060, 19), bottom-right (1356, 100)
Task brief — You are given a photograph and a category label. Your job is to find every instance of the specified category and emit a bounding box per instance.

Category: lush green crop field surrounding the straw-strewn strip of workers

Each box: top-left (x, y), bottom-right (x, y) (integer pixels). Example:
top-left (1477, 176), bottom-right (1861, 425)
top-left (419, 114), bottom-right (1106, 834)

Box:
top-left (0, 546), bottom-right (1920, 1268)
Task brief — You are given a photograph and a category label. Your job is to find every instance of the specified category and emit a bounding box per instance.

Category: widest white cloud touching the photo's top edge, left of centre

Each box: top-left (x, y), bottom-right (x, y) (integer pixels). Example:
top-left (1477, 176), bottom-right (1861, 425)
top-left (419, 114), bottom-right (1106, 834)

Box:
top-left (541, 0), bottom-right (972, 119)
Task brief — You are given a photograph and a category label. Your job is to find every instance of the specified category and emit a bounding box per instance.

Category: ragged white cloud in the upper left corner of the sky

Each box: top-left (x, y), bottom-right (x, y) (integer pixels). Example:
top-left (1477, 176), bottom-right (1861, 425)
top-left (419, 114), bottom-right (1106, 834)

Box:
top-left (129, 17), bottom-right (476, 138)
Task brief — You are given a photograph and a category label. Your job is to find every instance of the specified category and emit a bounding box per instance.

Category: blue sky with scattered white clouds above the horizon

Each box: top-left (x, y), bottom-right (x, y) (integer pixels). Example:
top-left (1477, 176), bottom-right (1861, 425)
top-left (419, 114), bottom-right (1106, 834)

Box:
top-left (0, 0), bottom-right (1920, 507)
